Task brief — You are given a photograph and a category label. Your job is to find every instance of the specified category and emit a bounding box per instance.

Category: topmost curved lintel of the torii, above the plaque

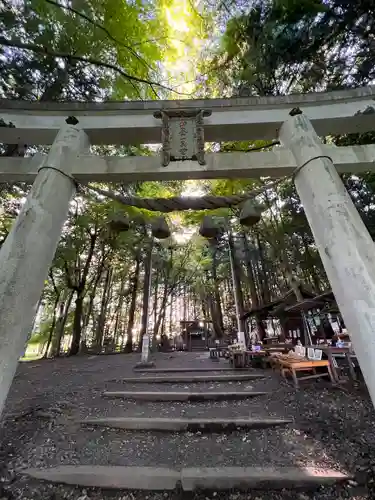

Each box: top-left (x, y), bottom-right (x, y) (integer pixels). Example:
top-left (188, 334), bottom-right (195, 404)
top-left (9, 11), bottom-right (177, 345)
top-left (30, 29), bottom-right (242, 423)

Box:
top-left (0, 86), bottom-right (375, 145)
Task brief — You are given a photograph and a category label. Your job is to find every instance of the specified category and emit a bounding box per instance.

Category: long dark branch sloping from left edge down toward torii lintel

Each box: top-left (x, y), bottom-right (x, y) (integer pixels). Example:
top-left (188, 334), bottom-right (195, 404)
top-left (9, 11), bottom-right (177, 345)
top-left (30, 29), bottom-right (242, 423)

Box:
top-left (0, 36), bottom-right (190, 95)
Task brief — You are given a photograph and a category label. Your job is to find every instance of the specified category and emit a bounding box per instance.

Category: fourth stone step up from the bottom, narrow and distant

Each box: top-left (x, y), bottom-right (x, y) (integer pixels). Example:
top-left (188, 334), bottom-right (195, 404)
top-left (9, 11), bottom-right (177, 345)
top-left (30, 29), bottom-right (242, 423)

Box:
top-left (116, 373), bottom-right (265, 384)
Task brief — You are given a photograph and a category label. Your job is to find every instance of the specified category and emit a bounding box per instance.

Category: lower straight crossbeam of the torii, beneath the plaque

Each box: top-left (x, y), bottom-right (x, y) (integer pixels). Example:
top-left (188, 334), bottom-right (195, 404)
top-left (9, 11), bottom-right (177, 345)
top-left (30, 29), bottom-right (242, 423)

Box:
top-left (0, 145), bottom-right (375, 183)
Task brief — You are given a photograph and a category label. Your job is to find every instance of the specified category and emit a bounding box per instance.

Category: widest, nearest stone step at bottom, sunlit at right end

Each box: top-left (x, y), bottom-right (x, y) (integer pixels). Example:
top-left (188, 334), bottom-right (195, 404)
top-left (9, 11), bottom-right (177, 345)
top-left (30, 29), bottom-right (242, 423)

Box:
top-left (21, 465), bottom-right (350, 491)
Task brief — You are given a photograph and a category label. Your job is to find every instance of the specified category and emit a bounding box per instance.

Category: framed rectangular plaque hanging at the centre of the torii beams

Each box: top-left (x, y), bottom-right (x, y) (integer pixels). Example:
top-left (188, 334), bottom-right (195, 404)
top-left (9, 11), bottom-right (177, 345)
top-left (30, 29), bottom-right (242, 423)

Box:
top-left (154, 109), bottom-right (211, 167)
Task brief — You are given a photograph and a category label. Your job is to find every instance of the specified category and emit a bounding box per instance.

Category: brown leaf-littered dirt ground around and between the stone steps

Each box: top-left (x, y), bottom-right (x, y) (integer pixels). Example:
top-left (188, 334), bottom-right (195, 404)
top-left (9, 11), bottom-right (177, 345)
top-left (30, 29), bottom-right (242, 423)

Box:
top-left (0, 353), bottom-right (375, 500)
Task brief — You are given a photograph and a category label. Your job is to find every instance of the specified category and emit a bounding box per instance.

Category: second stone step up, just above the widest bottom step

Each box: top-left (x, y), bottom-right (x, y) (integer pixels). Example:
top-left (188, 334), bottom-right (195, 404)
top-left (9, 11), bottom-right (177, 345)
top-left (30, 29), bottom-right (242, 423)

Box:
top-left (79, 417), bottom-right (293, 432)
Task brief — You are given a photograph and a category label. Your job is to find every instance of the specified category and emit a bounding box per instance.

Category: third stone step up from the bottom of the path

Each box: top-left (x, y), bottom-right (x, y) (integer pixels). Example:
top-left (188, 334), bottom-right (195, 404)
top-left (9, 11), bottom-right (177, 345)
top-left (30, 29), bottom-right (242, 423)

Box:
top-left (103, 391), bottom-right (267, 402)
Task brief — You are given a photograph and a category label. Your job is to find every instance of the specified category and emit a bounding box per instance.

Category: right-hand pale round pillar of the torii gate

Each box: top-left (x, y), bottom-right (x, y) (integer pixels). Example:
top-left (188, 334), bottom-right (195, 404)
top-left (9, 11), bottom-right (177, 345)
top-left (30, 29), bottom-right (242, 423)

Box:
top-left (280, 114), bottom-right (375, 405)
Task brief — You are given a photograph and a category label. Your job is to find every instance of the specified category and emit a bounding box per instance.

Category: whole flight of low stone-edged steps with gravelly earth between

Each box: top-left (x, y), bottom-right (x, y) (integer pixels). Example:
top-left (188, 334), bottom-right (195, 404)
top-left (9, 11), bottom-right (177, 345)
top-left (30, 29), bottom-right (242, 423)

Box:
top-left (22, 353), bottom-right (350, 499)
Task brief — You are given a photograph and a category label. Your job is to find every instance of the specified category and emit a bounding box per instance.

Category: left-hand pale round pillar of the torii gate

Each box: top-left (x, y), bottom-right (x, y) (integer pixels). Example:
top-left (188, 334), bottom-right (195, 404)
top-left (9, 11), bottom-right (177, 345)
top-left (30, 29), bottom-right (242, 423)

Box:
top-left (0, 124), bottom-right (89, 415)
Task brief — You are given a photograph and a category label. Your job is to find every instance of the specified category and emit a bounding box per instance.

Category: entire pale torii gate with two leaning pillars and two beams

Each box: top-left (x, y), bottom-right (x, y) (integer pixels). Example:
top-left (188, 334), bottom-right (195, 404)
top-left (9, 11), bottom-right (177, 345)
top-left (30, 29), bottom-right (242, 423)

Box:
top-left (0, 87), bottom-right (375, 413)
